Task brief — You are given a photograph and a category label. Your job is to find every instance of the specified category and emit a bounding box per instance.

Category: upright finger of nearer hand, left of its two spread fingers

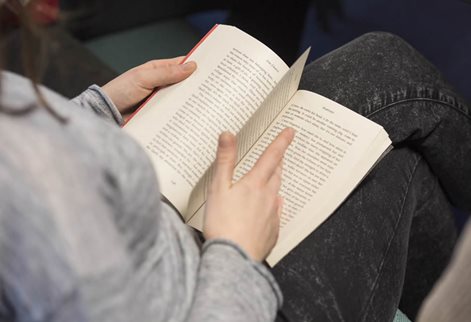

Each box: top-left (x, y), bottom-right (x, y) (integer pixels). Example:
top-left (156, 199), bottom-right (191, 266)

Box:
top-left (213, 132), bottom-right (237, 188)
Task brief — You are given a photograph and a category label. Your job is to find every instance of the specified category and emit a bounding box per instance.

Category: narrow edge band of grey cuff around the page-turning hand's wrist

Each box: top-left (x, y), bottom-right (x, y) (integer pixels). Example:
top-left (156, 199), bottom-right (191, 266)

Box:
top-left (202, 238), bottom-right (283, 310)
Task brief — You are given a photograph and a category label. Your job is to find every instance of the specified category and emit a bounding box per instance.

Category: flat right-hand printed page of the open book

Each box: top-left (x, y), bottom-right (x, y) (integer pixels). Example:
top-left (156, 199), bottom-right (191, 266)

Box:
top-left (232, 91), bottom-right (391, 265)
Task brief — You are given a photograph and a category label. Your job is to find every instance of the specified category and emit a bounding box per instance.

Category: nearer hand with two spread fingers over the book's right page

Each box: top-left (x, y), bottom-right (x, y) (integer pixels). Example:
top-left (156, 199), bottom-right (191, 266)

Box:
top-left (203, 128), bottom-right (294, 261)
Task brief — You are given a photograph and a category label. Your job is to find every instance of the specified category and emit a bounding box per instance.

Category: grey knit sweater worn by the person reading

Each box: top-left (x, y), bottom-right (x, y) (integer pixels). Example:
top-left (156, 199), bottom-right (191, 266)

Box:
top-left (0, 72), bottom-right (281, 322)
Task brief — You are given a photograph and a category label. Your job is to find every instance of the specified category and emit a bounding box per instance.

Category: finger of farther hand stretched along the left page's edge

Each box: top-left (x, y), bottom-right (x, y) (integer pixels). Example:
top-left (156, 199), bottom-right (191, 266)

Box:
top-left (136, 62), bottom-right (196, 90)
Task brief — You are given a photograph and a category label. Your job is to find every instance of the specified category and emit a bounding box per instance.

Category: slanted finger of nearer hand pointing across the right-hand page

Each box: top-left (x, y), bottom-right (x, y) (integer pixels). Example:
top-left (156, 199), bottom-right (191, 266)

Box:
top-left (249, 128), bottom-right (294, 182)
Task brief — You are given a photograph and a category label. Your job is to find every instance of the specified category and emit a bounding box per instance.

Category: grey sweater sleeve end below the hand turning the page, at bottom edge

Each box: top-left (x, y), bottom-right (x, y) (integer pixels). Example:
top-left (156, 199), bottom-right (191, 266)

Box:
top-left (188, 239), bottom-right (283, 322)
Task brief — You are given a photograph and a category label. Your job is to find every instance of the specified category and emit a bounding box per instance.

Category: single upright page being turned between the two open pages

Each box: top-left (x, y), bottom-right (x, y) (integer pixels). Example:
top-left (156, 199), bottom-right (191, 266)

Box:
top-left (184, 49), bottom-right (310, 221)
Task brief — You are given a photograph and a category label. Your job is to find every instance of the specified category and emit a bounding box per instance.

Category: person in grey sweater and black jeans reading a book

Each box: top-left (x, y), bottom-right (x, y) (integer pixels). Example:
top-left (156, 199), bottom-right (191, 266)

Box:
top-left (0, 2), bottom-right (471, 321)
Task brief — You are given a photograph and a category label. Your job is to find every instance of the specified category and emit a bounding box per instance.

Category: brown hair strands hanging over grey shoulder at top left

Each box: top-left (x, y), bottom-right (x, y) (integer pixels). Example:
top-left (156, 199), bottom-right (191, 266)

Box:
top-left (0, 0), bottom-right (66, 122)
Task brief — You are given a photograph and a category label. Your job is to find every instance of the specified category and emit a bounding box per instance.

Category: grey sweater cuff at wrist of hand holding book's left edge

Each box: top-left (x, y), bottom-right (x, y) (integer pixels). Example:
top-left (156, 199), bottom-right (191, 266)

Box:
top-left (72, 85), bottom-right (123, 125)
